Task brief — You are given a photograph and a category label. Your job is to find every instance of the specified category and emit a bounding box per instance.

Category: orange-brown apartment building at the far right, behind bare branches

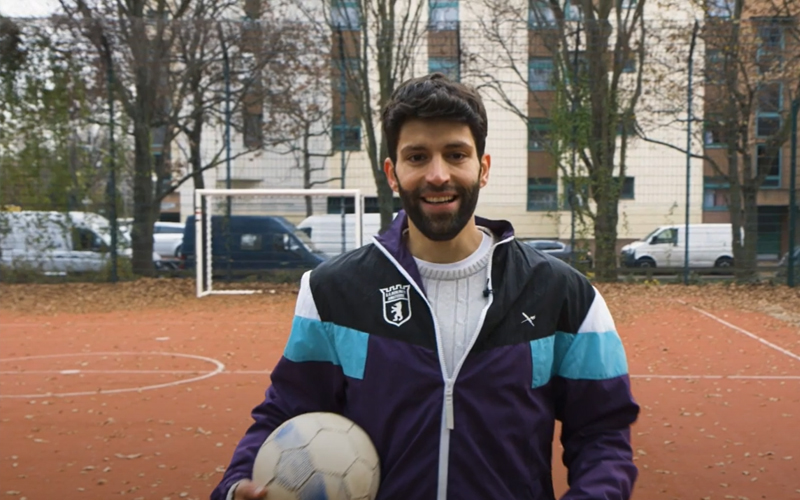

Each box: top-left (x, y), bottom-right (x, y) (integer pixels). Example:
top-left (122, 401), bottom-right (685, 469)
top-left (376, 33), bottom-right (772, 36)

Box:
top-left (703, 0), bottom-right (800, 258)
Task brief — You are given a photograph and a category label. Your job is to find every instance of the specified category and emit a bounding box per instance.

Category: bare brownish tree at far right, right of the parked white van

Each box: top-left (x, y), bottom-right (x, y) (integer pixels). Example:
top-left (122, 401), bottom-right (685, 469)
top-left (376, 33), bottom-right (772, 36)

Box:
top-left (645, 0), bottom-right (800, 282)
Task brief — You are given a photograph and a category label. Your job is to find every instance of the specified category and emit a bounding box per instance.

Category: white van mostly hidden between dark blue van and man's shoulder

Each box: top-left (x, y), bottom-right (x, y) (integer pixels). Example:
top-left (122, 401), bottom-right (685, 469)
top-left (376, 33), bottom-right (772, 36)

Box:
top-left (297, 214), bottom-right (397, 256)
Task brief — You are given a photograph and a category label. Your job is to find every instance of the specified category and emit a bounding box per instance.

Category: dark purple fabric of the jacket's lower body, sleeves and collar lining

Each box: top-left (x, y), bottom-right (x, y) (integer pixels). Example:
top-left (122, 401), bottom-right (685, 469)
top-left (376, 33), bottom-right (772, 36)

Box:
top-left (211, 214), bottom-right (638, 500)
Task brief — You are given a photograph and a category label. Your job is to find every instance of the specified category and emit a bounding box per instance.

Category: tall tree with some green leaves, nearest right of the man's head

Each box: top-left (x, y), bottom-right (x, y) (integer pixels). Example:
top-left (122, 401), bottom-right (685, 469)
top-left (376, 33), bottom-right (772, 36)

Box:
top-left (465, 0), bottom-right (647, 281)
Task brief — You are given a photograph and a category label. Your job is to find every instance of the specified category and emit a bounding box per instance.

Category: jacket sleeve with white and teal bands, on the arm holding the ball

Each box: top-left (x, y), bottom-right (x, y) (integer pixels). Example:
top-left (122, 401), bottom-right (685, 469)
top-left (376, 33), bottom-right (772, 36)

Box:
top-left (211, 271), bottom-right (344, 500)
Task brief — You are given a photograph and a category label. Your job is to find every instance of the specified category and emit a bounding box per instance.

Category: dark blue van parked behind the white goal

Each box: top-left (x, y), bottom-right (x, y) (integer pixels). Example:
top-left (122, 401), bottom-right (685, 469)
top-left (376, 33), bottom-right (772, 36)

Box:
top-left (181, 215), bottom-right (326, 274)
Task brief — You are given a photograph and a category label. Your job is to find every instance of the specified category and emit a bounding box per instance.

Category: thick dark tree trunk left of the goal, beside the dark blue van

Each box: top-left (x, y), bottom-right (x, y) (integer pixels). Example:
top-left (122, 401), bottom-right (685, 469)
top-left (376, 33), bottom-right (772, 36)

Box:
top-left (131, 122), bottom-right (155, 276)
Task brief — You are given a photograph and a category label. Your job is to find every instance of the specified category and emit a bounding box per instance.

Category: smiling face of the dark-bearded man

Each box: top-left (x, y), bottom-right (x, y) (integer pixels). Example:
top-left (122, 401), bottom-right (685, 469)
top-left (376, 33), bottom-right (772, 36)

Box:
top-left (384, 120), bottom-right (490, 241)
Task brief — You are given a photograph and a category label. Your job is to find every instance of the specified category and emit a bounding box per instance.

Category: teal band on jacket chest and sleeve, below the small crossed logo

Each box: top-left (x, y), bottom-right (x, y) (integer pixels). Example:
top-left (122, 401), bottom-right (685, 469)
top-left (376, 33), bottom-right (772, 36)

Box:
top-left (530, 331), bottom-right (628, 389)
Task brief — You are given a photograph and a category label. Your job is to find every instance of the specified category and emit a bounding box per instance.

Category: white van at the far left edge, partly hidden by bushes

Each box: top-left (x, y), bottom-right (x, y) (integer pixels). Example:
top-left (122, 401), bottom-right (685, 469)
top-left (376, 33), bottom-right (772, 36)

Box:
top-left (0, 211), bottom-right (161, 275)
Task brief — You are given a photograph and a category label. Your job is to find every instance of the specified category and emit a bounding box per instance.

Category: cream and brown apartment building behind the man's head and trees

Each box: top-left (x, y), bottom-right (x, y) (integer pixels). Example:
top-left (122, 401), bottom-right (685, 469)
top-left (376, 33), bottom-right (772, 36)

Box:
top-left (175, 0), bottom-right (789, 252)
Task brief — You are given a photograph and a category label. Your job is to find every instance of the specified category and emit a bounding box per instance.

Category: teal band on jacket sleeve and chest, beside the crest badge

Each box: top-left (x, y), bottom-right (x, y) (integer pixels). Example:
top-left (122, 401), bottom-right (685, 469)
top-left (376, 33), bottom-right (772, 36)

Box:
top-left (283, 316), bottom-right (369, 379)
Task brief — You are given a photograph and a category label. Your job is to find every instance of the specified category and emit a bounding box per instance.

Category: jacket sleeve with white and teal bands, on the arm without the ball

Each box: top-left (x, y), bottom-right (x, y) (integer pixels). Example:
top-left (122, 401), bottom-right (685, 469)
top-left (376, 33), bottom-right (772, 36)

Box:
top-left (554, 282), bottom-right (639, 500)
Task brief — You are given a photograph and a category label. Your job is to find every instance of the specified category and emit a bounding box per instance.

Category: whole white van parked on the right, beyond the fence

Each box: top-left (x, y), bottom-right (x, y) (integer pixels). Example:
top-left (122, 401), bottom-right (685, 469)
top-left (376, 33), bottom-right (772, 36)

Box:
top-left (620, 224), bottom-right (733, 268)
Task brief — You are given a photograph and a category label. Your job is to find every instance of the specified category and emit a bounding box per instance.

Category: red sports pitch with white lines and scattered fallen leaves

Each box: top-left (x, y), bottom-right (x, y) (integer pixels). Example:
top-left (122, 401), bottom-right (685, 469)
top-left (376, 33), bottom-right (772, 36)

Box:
top-left (0, 296), bottom-right (800, 500)
